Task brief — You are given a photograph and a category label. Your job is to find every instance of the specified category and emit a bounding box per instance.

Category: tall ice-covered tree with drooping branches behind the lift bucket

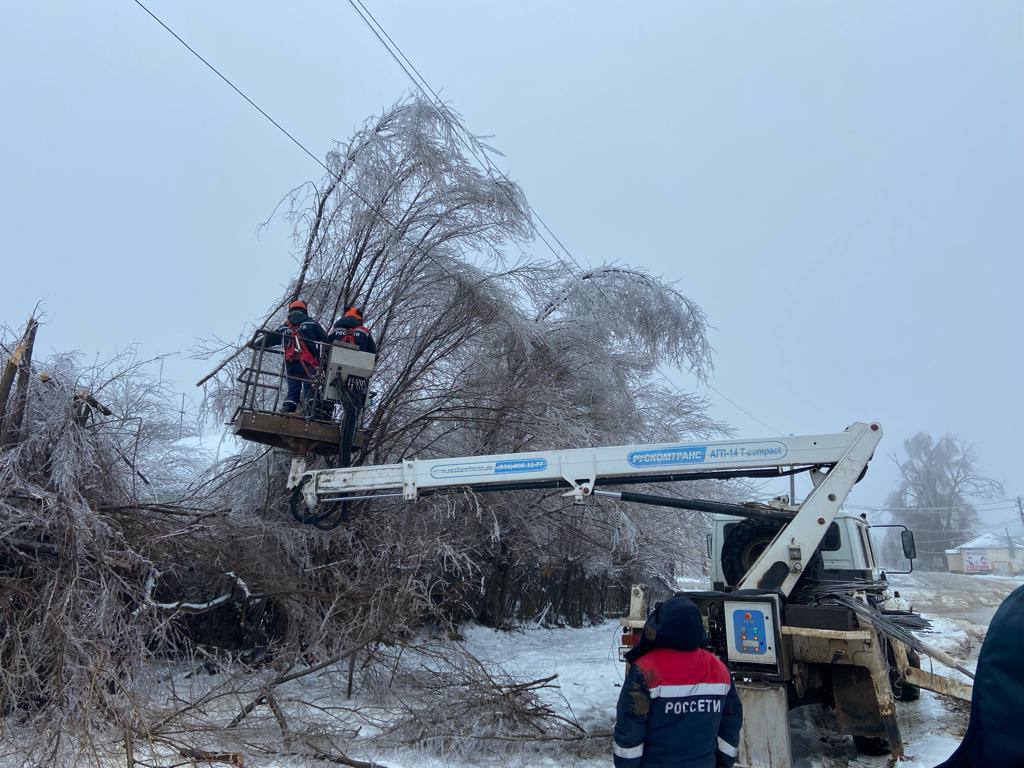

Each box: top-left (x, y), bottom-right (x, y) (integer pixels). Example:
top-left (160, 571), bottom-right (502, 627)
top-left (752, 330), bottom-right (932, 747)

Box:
top-left (203, 98), bottom-right (723, 621)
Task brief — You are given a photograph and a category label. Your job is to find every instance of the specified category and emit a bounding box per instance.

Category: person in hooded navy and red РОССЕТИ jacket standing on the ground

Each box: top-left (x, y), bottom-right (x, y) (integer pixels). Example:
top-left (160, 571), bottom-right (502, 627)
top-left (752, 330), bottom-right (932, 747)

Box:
top-left (613, 595), bottom-right (743, 768)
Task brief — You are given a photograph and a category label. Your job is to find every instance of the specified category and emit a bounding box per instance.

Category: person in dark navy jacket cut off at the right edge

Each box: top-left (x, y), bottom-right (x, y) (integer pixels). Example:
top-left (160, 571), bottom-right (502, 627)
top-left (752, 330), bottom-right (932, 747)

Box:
top-left (939, 587), bottom-right (1024, 768)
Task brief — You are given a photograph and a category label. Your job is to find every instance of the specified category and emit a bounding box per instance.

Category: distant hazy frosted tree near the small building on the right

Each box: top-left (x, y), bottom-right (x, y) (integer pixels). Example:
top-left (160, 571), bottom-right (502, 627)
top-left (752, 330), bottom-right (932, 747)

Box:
top-left (887, 432), bottom-right (1004, 570)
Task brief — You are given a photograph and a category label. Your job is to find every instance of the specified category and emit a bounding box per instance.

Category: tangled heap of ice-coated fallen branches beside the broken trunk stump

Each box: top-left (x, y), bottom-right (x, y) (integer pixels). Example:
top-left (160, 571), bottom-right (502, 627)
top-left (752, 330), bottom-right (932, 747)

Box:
top-left (0, 323), bottom-right (606, 766)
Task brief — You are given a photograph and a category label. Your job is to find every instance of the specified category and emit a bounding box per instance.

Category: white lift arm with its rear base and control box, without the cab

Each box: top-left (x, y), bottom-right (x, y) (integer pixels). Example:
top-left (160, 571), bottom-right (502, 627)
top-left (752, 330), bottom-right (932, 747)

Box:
top-left (288, 423), bottom-right (970, 768)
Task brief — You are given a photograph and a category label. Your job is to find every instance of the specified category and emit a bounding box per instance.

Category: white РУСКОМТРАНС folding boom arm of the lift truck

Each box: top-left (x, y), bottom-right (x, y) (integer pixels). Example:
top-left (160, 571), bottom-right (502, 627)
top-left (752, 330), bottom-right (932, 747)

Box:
top-left (288, 423), bottom-right (882, 594)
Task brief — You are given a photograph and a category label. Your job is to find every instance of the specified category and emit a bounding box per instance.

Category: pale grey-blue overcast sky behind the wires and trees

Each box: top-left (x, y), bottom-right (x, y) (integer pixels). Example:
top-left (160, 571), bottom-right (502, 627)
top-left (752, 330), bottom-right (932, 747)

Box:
top-left (0, 0), bottom-right (1024, 522)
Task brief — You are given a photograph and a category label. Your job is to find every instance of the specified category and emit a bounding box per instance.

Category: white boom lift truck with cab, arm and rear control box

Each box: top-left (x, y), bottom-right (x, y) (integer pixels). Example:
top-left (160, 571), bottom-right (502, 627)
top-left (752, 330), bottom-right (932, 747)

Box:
top-left (272, 423), bottom-right (973, 768)
